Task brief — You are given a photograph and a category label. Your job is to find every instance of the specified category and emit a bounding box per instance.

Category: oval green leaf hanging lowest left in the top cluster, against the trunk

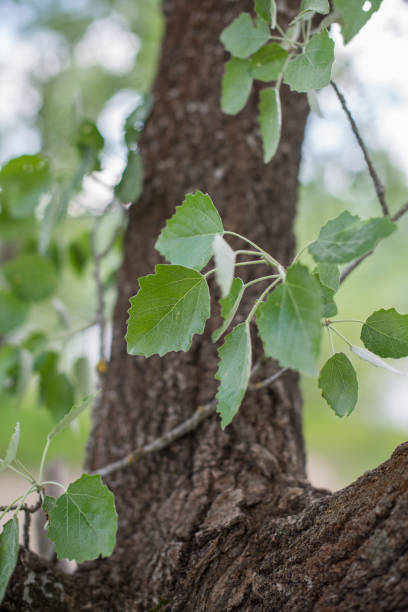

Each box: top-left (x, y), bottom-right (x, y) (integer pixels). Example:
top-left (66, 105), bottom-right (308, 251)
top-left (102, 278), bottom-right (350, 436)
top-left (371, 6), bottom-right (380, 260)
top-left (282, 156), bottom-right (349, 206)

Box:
top-left (221, 58), bottom-right (253, 115)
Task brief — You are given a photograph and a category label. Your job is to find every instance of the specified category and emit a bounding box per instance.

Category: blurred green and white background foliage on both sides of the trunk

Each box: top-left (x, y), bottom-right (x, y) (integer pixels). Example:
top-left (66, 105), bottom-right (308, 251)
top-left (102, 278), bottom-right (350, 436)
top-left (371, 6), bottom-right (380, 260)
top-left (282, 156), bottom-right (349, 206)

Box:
top-left (0, 0), bottom-right (408, 488)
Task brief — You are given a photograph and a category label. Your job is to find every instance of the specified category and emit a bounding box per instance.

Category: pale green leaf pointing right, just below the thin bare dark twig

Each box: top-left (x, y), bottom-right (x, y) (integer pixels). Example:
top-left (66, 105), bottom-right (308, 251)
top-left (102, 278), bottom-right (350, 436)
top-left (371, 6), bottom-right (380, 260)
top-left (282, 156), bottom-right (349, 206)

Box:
top-left (309, 210), bottom-right (397, 263)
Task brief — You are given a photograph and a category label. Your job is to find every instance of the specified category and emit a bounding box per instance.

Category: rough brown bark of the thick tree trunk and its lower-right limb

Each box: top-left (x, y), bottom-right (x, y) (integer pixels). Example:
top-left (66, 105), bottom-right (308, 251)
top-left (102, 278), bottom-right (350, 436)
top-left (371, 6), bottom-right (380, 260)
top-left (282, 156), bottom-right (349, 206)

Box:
top-left (2, 0), bottom-right (408, 612)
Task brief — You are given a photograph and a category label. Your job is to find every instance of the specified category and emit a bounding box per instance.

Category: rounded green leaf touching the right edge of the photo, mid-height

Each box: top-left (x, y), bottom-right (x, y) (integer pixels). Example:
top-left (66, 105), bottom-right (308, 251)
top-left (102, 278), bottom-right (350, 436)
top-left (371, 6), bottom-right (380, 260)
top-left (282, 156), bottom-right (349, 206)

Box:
top-left (360, 308), bottom-right (408, 359)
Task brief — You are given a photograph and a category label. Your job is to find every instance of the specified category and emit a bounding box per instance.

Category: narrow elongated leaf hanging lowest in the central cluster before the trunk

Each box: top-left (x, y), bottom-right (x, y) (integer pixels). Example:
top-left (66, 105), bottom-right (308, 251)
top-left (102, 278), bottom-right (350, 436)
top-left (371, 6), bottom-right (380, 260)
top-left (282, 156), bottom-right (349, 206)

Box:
top-left (215, 322), bottom-right (252, 429)
